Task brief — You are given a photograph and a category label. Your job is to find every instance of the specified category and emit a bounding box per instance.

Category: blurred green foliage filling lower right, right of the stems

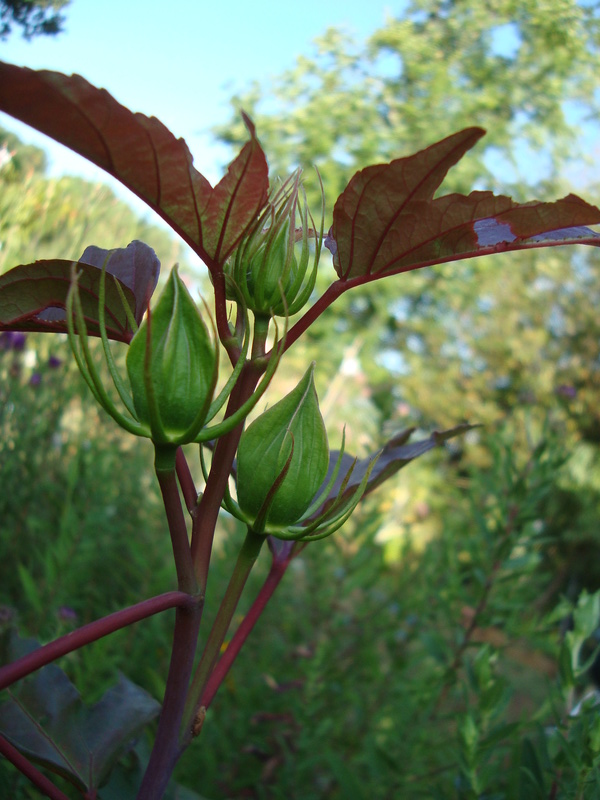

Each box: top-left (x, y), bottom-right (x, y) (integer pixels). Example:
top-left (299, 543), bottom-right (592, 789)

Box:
top-left (172, 419), bottom-right (598, 800)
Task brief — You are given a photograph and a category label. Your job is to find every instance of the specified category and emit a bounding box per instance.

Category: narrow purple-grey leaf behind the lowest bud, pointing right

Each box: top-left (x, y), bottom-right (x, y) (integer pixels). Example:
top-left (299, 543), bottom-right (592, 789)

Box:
top-left (311, 424), bottom-right (476, 519)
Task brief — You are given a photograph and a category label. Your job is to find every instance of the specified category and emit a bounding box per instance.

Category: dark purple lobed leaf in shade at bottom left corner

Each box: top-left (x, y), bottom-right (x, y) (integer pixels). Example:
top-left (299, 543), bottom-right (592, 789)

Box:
top-left (0, 634), bottom-right (160, 790)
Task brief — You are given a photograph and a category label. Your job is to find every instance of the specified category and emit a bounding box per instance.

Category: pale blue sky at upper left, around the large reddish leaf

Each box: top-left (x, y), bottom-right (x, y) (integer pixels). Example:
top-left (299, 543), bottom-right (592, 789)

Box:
top-left (0, 0), bottom-right (406, 189)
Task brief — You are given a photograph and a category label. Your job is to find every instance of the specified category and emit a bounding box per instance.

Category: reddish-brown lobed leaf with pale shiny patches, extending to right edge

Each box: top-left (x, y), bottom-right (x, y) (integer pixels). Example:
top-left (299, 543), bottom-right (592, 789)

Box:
top-left (325, 128), bottom-right (600, 280)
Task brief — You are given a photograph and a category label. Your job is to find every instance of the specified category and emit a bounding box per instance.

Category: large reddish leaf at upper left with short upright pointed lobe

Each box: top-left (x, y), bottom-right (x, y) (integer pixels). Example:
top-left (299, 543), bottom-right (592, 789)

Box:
top-left (0, 62), bottom-right (268, 269)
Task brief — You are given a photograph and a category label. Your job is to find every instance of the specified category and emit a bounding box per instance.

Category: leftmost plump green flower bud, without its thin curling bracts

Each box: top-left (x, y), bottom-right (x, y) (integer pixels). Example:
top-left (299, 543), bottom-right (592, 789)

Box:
top-left (127, 269), bottom-right (218, 445)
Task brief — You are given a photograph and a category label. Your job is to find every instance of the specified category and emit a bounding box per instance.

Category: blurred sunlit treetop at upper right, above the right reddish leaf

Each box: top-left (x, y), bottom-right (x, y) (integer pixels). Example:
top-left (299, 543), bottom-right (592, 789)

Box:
top-left (219, 0), bottom-right (600, 197)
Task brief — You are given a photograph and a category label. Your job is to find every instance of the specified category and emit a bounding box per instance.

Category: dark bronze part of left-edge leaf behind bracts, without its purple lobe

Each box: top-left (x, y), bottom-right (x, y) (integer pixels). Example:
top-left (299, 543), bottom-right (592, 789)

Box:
top-left (0, 259), bottom-right (136, 342)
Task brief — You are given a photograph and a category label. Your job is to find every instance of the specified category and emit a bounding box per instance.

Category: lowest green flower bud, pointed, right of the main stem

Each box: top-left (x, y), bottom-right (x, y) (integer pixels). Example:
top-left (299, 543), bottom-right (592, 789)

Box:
top-left (237, 364), bottom-right (329, 532)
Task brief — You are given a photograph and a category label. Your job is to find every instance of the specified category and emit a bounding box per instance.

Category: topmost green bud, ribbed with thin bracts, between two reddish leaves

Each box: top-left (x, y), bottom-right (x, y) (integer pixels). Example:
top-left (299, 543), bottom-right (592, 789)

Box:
top-left (225, 173), bottom-right (323, 317)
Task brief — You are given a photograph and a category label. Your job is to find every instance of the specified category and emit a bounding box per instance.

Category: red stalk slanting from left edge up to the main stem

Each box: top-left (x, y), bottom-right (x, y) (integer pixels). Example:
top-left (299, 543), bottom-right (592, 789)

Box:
top-left (0, 592), bottom-right (198, 690)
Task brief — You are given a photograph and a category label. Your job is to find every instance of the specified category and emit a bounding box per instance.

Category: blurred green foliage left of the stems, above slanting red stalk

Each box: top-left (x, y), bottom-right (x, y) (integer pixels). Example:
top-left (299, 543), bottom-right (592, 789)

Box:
top-left (0, 335), bottom-right (171, 636)
